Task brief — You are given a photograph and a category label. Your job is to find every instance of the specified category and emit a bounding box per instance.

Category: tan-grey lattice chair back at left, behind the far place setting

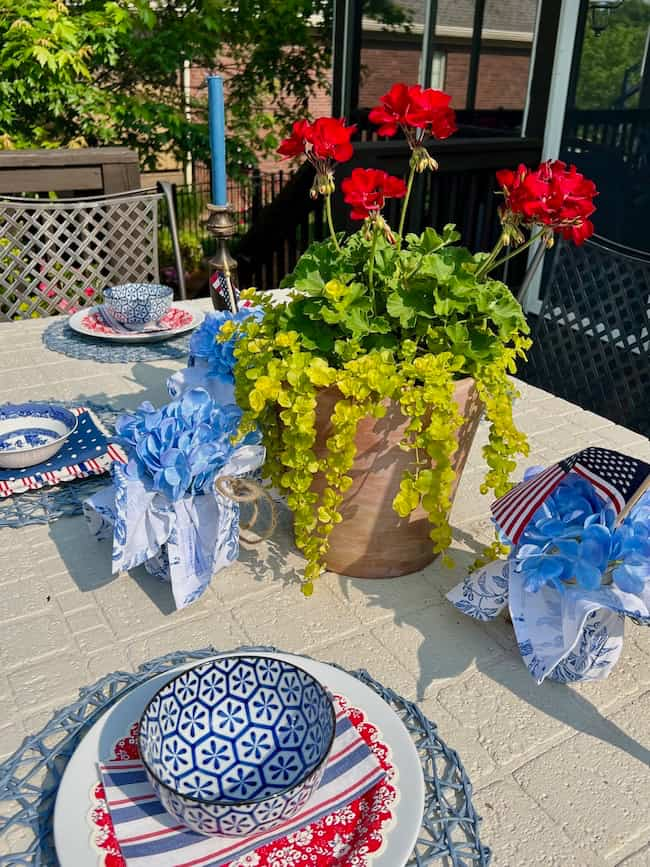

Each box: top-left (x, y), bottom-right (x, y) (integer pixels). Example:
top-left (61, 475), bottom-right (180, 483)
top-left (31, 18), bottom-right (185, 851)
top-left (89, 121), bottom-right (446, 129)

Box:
top-left (0, 188), bottom-right (184, 321)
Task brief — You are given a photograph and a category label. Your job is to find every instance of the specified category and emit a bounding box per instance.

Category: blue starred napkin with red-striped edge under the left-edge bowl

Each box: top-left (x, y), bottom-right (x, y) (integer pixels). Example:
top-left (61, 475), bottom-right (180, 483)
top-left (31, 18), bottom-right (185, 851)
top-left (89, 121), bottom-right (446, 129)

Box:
top-left (0, 406), bottom-right (125, 497)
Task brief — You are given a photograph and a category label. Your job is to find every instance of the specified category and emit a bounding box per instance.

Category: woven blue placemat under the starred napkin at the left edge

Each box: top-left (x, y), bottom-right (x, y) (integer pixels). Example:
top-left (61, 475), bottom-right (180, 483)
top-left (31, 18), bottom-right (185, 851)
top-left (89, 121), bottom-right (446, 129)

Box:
top-left (0, 400), bottom-right (121, 528)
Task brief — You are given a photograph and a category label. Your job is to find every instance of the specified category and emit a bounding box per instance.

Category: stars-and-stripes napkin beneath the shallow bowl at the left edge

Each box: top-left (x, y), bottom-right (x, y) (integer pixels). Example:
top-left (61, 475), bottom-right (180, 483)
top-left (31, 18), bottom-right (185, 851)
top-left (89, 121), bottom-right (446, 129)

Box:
top-left (0, 406), bottom-right (126, 498)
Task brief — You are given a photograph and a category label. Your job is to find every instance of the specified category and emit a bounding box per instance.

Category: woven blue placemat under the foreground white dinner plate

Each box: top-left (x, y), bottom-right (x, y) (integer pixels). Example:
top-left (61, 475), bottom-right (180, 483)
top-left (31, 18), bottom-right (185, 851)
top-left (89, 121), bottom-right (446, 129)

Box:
top-left (0, 647), bottom-right (491, 867)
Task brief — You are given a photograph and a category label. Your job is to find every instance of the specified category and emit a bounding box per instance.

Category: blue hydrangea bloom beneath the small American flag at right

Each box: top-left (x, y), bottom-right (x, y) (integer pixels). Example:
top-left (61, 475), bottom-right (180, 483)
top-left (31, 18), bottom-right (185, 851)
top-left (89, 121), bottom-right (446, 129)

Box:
top-left (511, 470), bottom-right (650, 593)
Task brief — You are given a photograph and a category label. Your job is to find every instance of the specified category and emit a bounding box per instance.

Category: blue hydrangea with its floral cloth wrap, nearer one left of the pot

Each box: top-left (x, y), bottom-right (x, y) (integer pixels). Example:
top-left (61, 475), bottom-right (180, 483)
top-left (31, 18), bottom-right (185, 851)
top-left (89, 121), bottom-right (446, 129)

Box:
top-left (84, 388), bottom-right (265, 608)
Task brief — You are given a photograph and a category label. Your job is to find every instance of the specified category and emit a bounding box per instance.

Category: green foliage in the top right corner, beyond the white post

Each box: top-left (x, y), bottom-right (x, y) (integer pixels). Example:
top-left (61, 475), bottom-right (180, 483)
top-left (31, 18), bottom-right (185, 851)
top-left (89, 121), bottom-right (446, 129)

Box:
top-left (576, 0), bottom-right (650, 109)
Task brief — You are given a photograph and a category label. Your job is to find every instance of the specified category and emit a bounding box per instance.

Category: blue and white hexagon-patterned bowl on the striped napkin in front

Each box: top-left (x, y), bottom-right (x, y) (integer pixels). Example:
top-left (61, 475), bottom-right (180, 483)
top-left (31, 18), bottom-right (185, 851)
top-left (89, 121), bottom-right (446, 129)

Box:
top-left (139, 656), bottom-right (336, 837)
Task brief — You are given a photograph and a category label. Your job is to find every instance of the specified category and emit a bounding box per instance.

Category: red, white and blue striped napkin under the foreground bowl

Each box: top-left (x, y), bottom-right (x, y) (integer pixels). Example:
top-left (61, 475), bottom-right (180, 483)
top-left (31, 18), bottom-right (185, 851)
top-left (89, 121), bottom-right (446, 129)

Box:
top-left (99, 699), bottom-right (385, 867)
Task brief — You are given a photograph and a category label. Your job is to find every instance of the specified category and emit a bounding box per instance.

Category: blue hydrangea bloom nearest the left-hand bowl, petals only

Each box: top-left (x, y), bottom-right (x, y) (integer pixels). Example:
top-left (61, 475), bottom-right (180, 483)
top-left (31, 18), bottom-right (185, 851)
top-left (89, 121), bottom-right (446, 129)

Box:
top-left (115, 388), bottom-right (254, 501)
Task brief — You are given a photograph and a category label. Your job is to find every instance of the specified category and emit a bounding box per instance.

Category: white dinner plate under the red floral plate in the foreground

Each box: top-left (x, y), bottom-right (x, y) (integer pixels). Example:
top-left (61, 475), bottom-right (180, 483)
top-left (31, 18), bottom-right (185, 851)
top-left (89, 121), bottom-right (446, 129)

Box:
top-left (54, 651), bottom-right (424, 867)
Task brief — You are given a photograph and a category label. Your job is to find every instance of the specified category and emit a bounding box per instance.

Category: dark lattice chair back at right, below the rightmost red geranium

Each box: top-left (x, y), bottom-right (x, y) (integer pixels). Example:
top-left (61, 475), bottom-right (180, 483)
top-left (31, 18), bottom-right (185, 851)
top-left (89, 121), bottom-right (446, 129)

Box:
top-left (521, 236), bottom-right (650, 435)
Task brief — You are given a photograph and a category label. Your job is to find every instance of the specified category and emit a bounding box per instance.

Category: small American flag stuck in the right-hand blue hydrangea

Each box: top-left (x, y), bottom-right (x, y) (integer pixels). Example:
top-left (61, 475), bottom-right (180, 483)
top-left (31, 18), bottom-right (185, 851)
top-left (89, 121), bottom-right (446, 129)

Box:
top-left (491, 448), bottom-right (650, 545)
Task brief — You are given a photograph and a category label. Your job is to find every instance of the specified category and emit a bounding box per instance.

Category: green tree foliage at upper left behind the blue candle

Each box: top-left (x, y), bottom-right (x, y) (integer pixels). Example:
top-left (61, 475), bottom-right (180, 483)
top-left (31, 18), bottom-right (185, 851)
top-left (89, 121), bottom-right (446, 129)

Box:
top-left (0, 0), bottom-right (405, 167)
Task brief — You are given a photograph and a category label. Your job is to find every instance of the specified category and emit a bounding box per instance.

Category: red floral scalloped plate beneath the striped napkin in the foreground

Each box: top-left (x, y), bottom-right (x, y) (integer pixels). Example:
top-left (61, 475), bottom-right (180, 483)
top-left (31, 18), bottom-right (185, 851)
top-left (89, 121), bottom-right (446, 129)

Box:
top-left (90, 696), bottom-right (398, 867)
